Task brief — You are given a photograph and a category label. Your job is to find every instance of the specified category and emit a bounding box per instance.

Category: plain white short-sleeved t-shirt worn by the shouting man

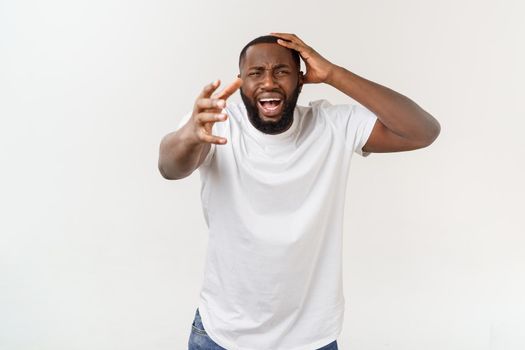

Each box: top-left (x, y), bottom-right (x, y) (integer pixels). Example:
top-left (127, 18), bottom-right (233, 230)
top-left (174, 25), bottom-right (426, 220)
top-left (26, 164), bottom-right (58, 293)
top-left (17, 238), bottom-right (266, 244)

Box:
top-left (176, 100), bottom-right (377, 350)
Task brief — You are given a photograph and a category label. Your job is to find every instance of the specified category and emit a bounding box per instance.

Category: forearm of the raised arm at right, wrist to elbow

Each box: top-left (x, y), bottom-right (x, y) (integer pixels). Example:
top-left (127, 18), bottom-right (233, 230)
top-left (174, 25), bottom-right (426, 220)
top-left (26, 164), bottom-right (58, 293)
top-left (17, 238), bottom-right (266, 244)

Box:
top-left (326, 66), bottom-right (440, 143)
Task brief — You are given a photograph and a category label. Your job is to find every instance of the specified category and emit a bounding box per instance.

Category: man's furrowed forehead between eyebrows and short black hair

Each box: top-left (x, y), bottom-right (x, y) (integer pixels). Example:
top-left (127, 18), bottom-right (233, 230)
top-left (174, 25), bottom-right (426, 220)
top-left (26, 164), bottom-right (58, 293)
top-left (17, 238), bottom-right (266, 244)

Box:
top-left (241, 43), bottom-right (295, 68)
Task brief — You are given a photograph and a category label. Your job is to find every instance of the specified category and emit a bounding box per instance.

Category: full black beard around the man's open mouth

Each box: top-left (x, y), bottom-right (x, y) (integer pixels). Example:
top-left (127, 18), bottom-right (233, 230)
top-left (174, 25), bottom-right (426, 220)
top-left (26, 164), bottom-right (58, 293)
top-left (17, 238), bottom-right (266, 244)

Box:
top-left (240, 85), bottom-right (301, 134)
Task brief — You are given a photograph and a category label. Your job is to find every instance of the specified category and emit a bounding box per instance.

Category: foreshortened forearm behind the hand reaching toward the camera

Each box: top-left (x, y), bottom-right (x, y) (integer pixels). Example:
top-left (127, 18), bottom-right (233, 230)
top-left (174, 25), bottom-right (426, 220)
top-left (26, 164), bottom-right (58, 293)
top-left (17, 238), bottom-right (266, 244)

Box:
top-left (159, 126), bottom-right (210, 180)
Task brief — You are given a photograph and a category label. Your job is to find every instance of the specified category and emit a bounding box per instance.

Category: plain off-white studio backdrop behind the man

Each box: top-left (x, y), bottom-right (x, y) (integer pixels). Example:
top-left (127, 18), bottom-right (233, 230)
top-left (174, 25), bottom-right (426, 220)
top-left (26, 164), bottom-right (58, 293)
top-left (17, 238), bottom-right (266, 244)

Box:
top-left (0, 0), bottom-right (525, 350)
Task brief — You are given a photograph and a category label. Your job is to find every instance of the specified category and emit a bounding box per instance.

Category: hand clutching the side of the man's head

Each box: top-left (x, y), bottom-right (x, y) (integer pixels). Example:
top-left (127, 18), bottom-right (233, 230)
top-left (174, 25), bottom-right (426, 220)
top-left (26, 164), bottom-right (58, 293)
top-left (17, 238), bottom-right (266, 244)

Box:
top-left (270, 33), bottom-right (335, 84)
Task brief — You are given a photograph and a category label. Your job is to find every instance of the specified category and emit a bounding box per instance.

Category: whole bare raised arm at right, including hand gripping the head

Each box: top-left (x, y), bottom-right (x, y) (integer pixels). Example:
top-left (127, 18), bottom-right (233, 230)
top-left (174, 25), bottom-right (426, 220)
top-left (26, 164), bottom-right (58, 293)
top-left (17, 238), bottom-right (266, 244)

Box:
top-left (271, 33), bottom-right (441, 153)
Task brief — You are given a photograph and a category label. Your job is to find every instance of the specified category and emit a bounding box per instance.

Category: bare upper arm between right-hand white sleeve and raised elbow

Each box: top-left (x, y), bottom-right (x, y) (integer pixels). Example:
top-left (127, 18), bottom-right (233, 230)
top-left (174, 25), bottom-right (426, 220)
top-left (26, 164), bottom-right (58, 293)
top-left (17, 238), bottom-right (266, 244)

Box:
top-left (362, 119), bottom-right (426, 153)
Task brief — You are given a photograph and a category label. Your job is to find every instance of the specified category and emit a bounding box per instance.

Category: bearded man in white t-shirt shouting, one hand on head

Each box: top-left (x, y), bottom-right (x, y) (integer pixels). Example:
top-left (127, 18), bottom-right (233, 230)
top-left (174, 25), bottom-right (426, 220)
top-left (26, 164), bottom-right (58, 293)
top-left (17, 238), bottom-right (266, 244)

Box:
top-left (159, 33), bottom-right (440, 350)
